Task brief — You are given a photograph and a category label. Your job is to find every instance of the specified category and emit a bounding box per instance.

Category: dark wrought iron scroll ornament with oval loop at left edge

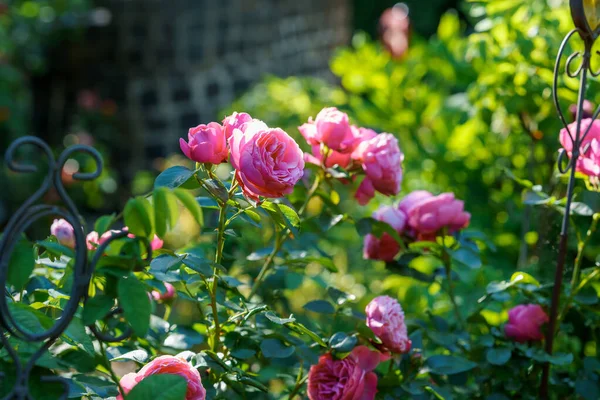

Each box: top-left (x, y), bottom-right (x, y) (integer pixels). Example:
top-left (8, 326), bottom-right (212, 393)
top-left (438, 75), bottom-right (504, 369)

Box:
top-left (0, 136), bottom-right (146, 400)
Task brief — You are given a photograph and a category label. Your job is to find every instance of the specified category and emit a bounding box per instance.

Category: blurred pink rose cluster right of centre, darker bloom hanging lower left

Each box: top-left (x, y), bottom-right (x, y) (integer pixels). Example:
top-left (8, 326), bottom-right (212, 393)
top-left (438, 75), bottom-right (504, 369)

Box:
top-left (363, 190), bottom-right (471, 261)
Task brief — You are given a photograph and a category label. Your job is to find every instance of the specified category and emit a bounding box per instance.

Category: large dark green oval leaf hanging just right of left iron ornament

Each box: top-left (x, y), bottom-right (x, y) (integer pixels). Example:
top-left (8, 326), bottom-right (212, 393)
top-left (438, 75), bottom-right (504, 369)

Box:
top-left (117, 274), bottom-right (152, 337)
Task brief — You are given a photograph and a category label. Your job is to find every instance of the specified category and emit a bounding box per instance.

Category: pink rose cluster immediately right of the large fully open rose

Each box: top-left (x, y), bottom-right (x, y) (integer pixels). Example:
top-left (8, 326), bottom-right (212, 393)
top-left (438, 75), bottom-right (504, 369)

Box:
top-left (298, 107), bottom-right (404, 205)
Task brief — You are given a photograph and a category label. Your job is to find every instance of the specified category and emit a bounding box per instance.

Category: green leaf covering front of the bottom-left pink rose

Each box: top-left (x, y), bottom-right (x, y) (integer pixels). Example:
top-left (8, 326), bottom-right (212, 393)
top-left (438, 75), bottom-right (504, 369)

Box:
top-left (127, 374), bottom-right (187, 400)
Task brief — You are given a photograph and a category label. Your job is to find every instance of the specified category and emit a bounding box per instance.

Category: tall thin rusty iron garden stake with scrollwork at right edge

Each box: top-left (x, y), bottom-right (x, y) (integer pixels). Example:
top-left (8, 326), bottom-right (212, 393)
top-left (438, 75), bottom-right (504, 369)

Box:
top-left (540, 0), bottom-right (600, 399)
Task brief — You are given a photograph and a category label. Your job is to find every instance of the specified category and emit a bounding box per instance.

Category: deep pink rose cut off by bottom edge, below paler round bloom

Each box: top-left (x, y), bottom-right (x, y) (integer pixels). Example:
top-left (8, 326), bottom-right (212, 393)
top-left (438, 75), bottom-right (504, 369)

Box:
top-left (307, 346), bottom-right (386, 400)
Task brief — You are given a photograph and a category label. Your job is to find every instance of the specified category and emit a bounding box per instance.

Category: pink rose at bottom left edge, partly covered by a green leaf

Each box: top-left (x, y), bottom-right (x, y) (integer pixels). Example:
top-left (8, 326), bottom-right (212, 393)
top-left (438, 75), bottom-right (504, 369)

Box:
top-left (117, 356), bottom-right (206, 400)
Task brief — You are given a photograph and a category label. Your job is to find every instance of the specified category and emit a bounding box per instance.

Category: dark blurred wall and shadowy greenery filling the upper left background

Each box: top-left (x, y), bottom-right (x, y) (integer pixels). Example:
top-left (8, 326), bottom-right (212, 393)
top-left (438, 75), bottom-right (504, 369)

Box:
top-left (0, 0), bottom-right (458, 225)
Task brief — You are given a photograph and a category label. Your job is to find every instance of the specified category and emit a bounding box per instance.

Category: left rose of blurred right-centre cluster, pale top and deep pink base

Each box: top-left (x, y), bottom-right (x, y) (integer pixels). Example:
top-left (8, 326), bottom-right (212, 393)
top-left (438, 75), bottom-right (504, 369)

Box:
top-left (363, 206), bottom-right (406, 261)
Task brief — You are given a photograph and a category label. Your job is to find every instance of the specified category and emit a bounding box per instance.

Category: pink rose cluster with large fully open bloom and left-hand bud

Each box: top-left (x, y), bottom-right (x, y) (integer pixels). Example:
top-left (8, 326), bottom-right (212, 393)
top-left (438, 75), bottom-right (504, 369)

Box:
top-left (180, 112), bottom-right (304, 202)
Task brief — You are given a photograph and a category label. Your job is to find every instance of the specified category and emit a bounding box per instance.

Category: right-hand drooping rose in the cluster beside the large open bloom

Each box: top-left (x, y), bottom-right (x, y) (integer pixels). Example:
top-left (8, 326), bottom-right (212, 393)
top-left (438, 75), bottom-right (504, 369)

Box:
top-left (352, 133), bottom-right (404, 200)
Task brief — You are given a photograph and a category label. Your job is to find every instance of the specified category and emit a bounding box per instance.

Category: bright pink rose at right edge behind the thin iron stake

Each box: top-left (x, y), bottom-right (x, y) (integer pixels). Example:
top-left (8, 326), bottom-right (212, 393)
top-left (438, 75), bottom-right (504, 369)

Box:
top-left (559, 118), bottom-right (600, 177)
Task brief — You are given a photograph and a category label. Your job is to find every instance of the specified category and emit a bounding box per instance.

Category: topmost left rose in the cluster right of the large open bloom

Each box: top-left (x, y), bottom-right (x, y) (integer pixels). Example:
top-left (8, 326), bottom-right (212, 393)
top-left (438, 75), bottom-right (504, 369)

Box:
top-left (298, 107), bottom-right (355, 153)
